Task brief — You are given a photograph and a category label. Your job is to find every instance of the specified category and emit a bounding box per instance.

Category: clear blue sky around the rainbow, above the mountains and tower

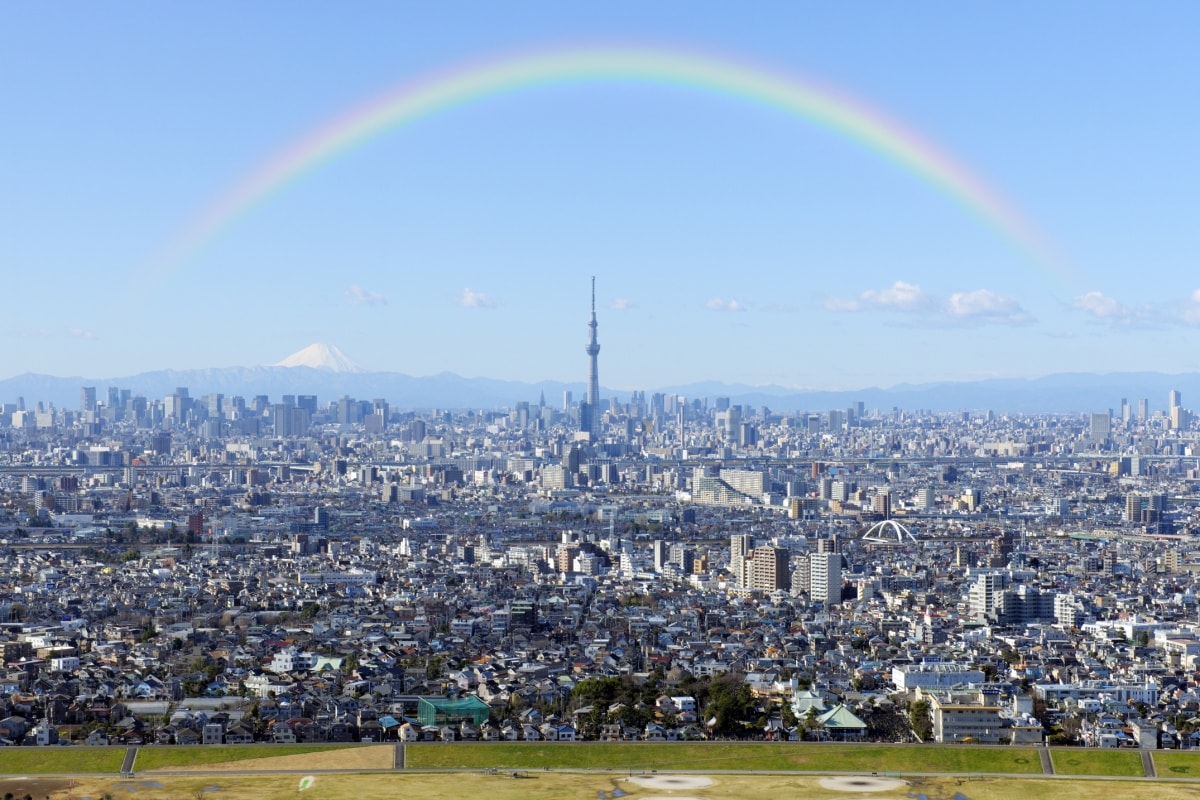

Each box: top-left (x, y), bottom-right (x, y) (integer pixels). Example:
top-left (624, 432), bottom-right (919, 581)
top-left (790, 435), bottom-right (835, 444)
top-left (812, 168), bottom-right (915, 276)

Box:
top-left (0, 1), bottom-right (1200, 389)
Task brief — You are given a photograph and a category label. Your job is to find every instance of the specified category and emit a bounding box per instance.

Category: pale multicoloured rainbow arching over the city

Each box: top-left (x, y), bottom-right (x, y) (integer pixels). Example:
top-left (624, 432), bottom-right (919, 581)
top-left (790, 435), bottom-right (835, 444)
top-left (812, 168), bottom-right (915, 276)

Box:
top-left (143, 46), bottom-right (1069, 285)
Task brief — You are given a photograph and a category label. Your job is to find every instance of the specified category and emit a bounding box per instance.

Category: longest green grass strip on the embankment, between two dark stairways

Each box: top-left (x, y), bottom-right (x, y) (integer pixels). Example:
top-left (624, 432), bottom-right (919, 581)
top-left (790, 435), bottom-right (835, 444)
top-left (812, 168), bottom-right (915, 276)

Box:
top-left (404, 742), bottom-right (1042, 775)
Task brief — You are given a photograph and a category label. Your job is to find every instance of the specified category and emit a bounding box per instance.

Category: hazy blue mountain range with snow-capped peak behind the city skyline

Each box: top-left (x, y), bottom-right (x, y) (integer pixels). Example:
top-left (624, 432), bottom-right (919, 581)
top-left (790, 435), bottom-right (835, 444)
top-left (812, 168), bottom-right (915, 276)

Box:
top-left (0, 344), bottom-right (1200, 413)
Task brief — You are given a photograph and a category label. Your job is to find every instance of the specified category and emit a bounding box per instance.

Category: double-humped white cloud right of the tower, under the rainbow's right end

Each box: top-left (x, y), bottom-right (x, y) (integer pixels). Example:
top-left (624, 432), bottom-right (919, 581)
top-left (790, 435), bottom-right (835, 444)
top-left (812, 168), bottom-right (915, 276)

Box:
top-left (824, 281), bottom-right (1034, 325)
